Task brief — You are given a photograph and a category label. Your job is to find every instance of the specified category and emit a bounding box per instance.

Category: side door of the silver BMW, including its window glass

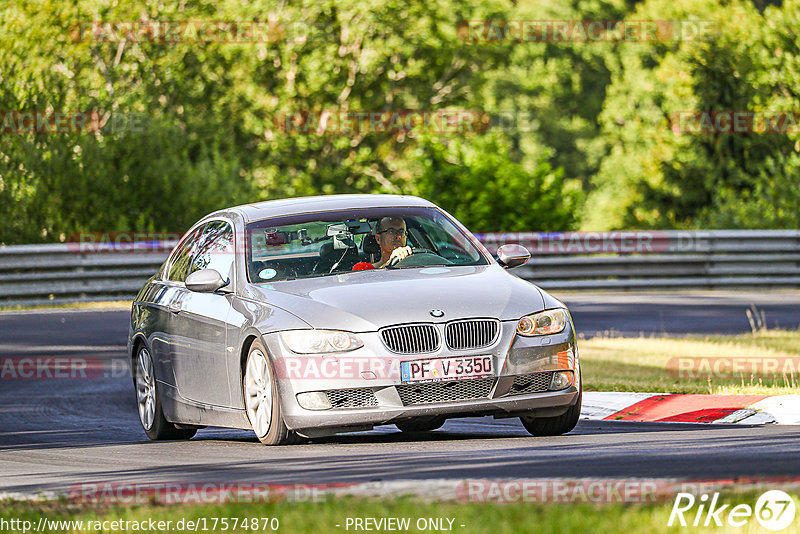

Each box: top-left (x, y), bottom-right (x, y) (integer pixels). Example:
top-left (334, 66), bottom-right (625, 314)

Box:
top-left (173, 220), bottom-right (234, 407)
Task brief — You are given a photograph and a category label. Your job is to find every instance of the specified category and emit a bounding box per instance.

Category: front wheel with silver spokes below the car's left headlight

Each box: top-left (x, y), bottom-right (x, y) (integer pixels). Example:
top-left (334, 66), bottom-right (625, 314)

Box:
top-left (242, 339), bottom-right (300, 445)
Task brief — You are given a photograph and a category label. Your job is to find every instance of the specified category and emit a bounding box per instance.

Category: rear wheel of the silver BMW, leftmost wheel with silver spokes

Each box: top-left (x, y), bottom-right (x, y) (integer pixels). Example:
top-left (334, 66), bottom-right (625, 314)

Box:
top-left (133, 345), bottom-right (197, 441)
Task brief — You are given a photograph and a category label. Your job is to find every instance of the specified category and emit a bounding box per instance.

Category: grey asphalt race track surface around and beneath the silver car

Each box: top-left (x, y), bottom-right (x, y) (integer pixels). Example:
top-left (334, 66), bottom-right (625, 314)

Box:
top-left (0, 292), bottom-right (800, 494)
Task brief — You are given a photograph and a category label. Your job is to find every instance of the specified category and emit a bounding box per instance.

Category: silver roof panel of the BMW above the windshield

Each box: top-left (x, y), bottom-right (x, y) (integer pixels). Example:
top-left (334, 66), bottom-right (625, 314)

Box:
top-left (219, 195), bottom-right (436, 223)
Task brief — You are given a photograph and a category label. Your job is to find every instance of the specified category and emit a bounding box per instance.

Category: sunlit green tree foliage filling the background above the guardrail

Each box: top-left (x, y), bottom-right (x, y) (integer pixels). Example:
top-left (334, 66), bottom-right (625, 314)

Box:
top-left (0, 0), bottom-right (800, 243)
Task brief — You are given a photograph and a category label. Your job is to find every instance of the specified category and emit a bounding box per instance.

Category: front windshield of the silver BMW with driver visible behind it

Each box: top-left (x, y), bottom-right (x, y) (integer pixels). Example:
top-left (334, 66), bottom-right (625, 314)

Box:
top-left (247, 208), bottom-right (489, 283)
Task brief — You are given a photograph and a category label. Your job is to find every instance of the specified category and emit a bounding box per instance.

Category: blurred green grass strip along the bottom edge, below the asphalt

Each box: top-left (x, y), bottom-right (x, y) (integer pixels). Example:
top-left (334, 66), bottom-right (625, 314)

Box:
top-left (0, 492), bottom-right (800, 534)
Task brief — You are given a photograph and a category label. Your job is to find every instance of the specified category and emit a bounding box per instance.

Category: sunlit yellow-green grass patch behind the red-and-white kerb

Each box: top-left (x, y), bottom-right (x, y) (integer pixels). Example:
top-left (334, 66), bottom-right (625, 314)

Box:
top-left (578, 330), bottom-right (800, 395)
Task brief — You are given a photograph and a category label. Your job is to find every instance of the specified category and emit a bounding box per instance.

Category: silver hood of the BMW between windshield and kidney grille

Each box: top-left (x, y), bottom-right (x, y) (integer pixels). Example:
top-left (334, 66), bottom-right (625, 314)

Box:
top-left (243, 265), bottom-right (544, 332)
